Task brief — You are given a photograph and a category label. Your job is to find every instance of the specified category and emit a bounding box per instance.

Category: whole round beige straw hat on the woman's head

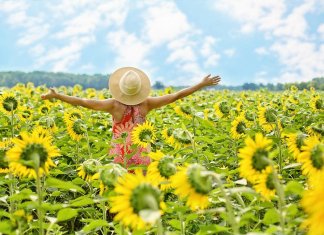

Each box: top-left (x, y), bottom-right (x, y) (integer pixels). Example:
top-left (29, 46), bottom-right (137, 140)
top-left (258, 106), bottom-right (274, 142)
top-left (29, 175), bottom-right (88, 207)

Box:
top-left (109, 67), bottom-right (151, 105)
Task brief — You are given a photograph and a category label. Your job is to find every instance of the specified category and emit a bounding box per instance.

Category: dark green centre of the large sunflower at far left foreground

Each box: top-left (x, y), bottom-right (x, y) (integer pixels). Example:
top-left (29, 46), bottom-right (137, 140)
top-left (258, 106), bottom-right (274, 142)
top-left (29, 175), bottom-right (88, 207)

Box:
top-left (21, 143), bottom-right (48, 167)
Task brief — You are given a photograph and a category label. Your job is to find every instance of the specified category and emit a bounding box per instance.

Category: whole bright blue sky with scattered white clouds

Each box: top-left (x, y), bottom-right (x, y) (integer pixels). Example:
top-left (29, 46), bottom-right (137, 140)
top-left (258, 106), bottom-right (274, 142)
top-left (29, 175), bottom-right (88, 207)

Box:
top-left (0, 0), bottom-right (324, 86)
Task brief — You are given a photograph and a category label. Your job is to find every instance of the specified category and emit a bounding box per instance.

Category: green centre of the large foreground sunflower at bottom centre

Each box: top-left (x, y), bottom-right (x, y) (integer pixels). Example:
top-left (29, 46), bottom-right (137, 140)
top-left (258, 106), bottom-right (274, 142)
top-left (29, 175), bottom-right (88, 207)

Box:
top-left (130, 183), bottom-right (160, 214)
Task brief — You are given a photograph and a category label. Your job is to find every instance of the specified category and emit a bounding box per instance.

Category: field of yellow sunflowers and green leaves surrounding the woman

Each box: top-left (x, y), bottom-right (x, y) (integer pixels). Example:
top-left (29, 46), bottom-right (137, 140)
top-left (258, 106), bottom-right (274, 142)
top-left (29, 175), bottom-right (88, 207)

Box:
top-left (0, 83), bottom-right (324, 235)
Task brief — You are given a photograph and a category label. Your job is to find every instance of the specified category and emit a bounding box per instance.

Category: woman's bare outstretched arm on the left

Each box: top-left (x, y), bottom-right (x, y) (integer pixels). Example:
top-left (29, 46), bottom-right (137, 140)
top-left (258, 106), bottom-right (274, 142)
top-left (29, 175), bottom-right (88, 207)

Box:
top-left (41, 88), bottom-right (114, 113)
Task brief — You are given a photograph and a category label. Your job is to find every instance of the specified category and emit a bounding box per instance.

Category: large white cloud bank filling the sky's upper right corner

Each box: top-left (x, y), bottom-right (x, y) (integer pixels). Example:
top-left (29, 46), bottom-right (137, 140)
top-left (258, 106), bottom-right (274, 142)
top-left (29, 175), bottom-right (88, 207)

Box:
top-left (214, 0), bottom-right (324, 82)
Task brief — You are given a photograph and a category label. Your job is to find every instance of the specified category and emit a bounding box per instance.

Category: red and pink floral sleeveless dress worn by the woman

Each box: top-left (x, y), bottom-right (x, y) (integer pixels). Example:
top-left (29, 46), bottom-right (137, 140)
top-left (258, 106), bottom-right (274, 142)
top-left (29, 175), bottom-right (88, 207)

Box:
top-left (109, 105), bottom-right (150, 168)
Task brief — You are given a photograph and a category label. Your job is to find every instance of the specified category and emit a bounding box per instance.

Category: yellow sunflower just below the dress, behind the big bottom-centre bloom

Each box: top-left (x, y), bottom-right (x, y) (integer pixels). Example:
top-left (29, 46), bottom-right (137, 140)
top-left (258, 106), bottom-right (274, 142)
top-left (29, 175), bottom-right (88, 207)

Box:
top-left (147, 151), bottom-right (176, 191)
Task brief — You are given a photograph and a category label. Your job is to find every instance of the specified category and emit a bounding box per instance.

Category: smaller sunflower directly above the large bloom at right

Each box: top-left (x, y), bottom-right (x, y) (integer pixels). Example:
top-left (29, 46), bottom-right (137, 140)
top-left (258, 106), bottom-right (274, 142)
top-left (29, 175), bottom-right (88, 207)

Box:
top-left (259, 106), bottom-right (280, 132)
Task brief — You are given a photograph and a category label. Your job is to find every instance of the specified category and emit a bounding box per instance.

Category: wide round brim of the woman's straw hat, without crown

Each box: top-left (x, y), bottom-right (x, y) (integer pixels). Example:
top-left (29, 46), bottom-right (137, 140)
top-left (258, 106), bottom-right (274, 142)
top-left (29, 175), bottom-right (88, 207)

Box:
top-left (109, 67), bottom-right (151, 105)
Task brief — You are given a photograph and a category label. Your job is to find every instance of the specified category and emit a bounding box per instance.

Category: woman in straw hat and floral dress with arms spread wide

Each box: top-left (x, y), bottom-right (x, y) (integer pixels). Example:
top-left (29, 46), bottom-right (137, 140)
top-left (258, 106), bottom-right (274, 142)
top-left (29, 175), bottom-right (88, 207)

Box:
top-left (41, 67), bottom-right (220, 167)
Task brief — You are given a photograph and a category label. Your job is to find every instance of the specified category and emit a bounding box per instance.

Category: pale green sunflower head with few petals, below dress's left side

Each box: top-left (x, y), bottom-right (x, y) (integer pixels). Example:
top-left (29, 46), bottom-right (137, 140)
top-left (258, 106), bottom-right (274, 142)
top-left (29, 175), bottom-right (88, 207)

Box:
top-left (99, 163), bottom-right (127, 195)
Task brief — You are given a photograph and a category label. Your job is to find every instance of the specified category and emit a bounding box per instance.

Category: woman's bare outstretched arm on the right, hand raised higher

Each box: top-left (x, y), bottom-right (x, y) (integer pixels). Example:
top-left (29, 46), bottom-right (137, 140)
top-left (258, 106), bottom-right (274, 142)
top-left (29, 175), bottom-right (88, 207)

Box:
top-left (147, 74), bottom-right (221, 111)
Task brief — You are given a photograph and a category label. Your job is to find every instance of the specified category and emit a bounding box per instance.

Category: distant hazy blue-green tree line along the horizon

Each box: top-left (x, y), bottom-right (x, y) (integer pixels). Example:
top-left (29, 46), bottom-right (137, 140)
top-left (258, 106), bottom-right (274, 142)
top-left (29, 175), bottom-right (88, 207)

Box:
top-left (0, 71), bottom-right (324, 91)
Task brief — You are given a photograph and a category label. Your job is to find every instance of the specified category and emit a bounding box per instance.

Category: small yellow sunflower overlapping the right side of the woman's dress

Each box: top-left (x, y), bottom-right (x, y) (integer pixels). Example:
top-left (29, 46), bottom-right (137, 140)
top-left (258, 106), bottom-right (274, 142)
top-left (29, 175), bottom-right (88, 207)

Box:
top-left (132, 121), bottom-right (155, 148)
